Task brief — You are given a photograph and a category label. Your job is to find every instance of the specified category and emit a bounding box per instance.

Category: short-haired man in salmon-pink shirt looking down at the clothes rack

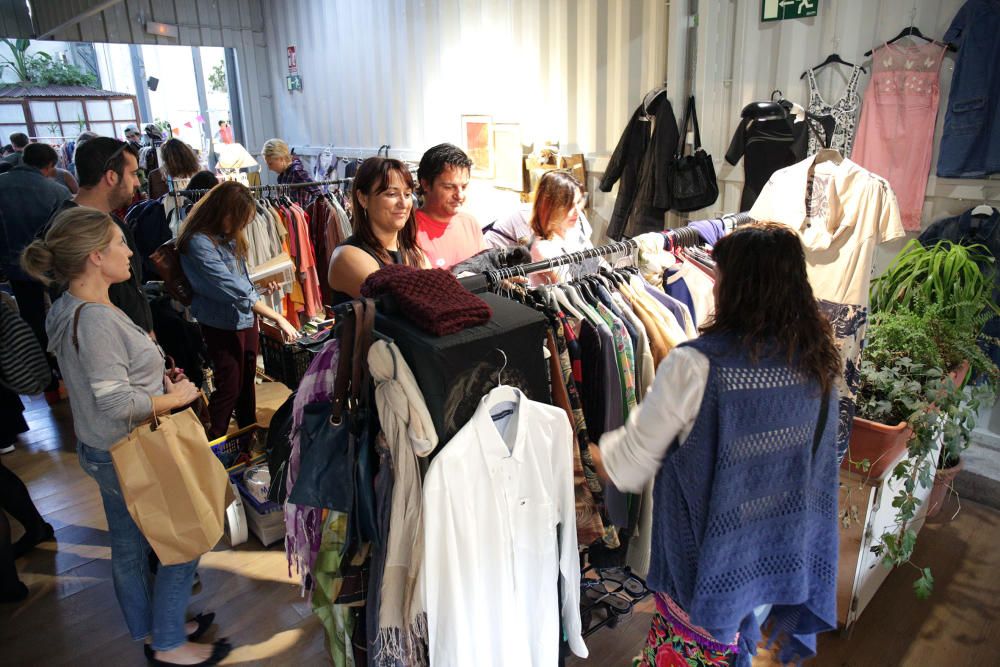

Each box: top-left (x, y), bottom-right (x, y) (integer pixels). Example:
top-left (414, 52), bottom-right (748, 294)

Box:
top-left (416, 144), bottom-right (489, 269)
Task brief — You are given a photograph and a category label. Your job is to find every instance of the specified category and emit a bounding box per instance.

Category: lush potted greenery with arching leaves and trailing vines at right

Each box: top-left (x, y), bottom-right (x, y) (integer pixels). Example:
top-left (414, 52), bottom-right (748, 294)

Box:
top-left (858, 241), bottom-right (1000, 597)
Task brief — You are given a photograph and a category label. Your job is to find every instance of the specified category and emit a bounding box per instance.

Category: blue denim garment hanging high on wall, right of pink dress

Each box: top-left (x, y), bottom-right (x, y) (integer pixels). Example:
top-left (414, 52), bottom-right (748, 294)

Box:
top-left (937, 0), bottom-right (1000, 178)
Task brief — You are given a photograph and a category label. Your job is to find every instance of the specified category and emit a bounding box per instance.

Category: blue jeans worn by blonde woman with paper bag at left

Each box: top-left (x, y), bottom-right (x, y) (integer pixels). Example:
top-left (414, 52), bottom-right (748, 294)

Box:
top-left (77, 442), bottom-right (198, 651)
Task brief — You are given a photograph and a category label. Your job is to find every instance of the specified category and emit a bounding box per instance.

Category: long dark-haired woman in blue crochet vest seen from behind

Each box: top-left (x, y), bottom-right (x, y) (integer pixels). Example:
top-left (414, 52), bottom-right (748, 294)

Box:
top-left (591, 223), bottom-right (840, 667)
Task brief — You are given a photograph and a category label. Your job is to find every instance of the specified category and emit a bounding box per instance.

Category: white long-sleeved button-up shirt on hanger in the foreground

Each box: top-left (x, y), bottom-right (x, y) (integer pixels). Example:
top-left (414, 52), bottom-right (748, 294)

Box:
top-left (421, 386), bottom-right (587, 667)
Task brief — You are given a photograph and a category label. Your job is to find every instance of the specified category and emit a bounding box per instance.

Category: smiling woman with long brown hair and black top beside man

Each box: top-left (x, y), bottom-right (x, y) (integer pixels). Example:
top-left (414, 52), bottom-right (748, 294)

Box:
top-left (327, 157), bottom-right (427, 305)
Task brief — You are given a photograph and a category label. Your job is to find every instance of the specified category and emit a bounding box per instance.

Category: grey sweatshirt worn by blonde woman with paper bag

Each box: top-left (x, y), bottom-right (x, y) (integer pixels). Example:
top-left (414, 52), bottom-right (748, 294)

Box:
top-left (45, 292), bottom-right (164, 450)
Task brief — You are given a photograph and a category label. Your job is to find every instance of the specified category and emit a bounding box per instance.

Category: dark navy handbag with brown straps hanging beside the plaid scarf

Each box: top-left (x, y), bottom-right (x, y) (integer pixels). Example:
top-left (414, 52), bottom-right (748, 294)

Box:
top-left (288, 302), bottom-right (375, 513)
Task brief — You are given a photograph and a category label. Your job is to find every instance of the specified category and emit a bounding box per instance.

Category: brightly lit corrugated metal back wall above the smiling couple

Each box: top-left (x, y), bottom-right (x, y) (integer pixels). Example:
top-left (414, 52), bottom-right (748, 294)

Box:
top-left (266, 0), bottom-right (667, 157)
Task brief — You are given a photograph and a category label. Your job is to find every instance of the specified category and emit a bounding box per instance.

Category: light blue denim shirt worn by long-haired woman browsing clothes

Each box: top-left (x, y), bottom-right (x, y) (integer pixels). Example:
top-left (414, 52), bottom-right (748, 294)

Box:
top-left (181, 234), bottom-right (260, 331)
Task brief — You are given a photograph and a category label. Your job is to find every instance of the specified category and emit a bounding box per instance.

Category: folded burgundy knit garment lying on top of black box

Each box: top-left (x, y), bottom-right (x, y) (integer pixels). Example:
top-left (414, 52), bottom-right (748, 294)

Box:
top-left (361, 264), bottom-right (493, 336)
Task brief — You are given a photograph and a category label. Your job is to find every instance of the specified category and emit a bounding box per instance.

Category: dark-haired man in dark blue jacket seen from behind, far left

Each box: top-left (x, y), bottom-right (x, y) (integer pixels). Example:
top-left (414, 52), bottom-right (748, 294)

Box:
top-left (0, 141), bottom-right (70, 392)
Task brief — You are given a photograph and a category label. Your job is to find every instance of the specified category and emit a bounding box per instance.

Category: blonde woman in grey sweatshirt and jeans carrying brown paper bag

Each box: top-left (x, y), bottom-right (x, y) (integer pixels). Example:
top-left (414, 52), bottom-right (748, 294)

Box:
top-left (21, 206), bottom-right (231, 665)
